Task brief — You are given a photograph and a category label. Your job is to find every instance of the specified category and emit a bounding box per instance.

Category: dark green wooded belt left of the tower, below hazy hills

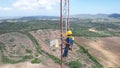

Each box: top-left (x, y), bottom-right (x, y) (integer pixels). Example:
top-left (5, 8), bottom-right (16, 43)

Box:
top-left (0, 20), bottom-right (59, 34)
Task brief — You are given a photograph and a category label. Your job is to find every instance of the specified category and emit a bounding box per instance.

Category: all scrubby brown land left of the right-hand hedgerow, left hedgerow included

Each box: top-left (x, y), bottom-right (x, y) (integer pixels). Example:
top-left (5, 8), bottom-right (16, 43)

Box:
top-left (0, 29), bottom-right (101, 68)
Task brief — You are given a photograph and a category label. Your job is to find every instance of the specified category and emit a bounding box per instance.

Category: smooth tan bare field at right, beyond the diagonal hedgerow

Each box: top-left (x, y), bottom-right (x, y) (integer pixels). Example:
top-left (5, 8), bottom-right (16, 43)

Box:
top-left (76, 37), bottom-right (120, 68)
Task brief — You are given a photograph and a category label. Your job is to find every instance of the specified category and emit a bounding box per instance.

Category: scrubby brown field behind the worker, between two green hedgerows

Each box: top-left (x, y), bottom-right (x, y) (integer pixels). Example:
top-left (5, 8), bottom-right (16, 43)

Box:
top-left (30, 29), bottom-right (99, 68)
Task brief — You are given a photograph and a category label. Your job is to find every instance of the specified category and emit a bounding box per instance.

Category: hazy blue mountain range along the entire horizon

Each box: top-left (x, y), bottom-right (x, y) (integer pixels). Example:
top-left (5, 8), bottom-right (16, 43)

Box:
top-left (0, 13), bottom-right (120, 20)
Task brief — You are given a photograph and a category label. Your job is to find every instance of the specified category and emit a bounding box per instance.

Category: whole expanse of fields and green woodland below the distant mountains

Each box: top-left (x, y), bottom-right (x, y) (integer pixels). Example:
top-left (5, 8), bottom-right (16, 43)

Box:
top-left (0, 19), bottom-right (120, 68)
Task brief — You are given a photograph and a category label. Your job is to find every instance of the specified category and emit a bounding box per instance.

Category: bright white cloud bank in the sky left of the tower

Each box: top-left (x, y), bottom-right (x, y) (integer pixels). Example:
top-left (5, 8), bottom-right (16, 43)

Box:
top-left (0, 0), bottom-right (59, 11)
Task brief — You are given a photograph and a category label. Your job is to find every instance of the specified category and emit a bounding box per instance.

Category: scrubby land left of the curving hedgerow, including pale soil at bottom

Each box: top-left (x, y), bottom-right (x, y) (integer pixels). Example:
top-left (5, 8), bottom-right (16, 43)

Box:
top-left (0, 32), bottom-right (67, 68)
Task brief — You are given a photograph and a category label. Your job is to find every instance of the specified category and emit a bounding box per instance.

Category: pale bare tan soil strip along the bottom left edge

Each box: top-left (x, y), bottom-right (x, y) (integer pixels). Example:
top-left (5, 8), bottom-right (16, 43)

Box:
top-left (0, 59), bottom-right (63, 68)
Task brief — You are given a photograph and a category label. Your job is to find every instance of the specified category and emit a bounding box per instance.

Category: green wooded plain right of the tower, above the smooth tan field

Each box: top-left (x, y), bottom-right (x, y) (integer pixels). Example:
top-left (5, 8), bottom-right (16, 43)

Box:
top-left (71, 21), bottom-right (120, 37)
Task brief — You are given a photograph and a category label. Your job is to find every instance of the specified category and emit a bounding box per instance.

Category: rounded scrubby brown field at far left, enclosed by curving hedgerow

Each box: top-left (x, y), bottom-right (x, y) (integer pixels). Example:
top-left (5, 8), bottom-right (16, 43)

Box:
top-left (0, 32), bottom-right (36, 63)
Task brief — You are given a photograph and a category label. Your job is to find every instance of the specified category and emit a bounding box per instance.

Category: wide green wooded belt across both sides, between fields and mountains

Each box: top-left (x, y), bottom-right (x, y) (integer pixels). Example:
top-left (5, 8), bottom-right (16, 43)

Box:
top-left (0, 19), bottom-right (120, 37)
